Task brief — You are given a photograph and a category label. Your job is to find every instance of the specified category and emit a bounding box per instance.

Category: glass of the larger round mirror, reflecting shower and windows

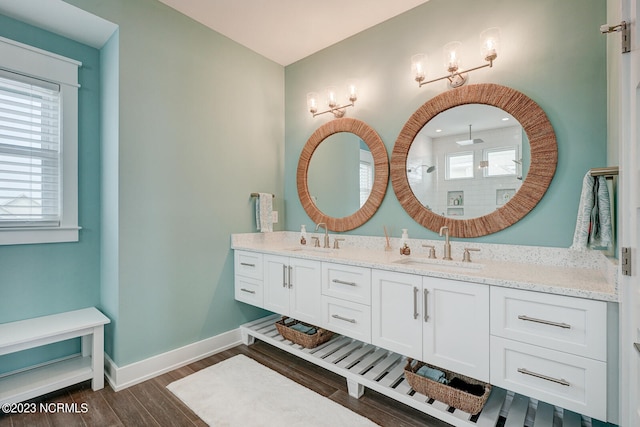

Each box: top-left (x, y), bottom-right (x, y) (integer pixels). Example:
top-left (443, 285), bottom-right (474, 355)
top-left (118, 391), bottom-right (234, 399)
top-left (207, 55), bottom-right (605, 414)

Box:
top-left (406, 104), bottom-right (530, 219)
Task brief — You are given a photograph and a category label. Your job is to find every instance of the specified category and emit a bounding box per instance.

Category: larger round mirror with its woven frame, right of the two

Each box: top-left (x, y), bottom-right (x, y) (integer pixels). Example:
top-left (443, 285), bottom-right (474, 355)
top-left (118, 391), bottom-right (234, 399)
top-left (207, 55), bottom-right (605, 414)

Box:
top-left (391, 84), bottom-right (558, 237)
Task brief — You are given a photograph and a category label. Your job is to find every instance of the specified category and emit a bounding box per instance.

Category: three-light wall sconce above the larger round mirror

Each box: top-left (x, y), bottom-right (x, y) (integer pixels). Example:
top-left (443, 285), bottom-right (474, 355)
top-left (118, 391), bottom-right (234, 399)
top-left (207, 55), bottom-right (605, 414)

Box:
top-left (411, 28), bottom-right (500, 88)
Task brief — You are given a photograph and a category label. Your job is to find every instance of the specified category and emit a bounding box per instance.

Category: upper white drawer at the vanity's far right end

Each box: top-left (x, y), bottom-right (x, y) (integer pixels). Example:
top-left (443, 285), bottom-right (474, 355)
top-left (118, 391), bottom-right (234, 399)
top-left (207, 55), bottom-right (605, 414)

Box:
top-left (491, 287), bottom-right (607, 361)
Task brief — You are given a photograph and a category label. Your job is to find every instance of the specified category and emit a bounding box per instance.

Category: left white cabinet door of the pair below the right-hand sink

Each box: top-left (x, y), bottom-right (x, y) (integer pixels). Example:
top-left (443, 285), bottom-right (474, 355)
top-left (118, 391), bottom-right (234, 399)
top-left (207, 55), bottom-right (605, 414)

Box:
top-left (371, 270), bottom-right (422, 360)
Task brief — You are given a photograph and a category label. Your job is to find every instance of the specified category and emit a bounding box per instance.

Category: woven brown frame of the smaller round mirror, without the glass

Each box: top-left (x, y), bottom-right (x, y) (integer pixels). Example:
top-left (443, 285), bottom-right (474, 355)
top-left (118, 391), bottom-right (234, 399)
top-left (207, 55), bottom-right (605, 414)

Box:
top-left (296, 118), bottom-right (389, 231)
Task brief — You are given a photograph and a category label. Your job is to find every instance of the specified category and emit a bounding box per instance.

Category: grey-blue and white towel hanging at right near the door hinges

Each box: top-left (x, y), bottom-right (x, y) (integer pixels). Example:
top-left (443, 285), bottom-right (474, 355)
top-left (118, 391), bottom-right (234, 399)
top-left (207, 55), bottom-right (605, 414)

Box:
top-left (571, 172), bottom-right (613, 250)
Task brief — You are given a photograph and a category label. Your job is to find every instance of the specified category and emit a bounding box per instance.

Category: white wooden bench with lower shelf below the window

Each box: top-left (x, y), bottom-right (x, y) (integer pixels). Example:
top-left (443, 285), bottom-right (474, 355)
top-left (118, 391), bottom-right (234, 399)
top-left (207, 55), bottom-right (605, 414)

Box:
top-left (0, 307), bottom-right (110, 404)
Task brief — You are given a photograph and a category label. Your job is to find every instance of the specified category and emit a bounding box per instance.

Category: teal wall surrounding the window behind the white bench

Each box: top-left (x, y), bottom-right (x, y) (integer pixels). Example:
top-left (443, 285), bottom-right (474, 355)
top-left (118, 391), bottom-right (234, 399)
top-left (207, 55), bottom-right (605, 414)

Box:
top-left (0, 15), bottom-right (100, 373)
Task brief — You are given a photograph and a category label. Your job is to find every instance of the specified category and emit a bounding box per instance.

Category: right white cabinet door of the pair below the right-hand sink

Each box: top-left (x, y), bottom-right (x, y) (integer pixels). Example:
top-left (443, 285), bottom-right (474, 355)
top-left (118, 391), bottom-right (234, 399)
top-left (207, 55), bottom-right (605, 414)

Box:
top-left (422, 277), bottom-right (489, 382)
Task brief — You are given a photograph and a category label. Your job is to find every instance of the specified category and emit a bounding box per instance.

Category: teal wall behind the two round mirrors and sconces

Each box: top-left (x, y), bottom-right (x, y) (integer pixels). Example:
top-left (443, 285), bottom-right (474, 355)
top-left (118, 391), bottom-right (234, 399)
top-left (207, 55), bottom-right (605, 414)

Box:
top-left (285, 0), bottom-right (607, 247)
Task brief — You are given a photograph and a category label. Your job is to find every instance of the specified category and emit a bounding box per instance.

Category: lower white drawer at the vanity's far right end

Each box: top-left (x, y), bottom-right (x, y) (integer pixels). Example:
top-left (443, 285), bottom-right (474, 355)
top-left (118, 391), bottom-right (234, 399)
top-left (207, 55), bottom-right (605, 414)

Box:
top-left (491, 337), bottom-right (607, 420)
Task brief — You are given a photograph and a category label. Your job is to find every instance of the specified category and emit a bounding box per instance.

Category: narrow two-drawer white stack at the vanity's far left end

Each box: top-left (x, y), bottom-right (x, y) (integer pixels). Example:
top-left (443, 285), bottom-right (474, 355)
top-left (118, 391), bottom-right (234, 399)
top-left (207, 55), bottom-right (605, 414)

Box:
top-left (233, 250), bottom-right (264, 307)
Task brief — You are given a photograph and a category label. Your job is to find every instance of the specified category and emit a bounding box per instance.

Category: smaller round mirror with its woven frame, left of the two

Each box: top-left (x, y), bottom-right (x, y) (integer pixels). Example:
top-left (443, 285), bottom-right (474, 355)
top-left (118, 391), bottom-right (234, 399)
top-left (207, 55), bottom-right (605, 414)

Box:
top-left (296, 118), bottom-right (389, 231)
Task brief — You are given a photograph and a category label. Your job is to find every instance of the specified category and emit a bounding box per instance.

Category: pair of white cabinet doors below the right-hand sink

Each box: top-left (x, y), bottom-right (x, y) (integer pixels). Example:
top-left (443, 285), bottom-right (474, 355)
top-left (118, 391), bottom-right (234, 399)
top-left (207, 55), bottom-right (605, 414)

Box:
top-left (371, 270), bottom-right (489, 382)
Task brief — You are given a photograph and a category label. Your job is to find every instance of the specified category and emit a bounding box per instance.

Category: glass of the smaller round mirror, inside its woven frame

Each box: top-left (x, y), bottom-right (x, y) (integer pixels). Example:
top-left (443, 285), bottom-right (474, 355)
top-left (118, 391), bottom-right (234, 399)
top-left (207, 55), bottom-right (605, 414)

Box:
top-left (307, 132), bottom-right (374, 218)
